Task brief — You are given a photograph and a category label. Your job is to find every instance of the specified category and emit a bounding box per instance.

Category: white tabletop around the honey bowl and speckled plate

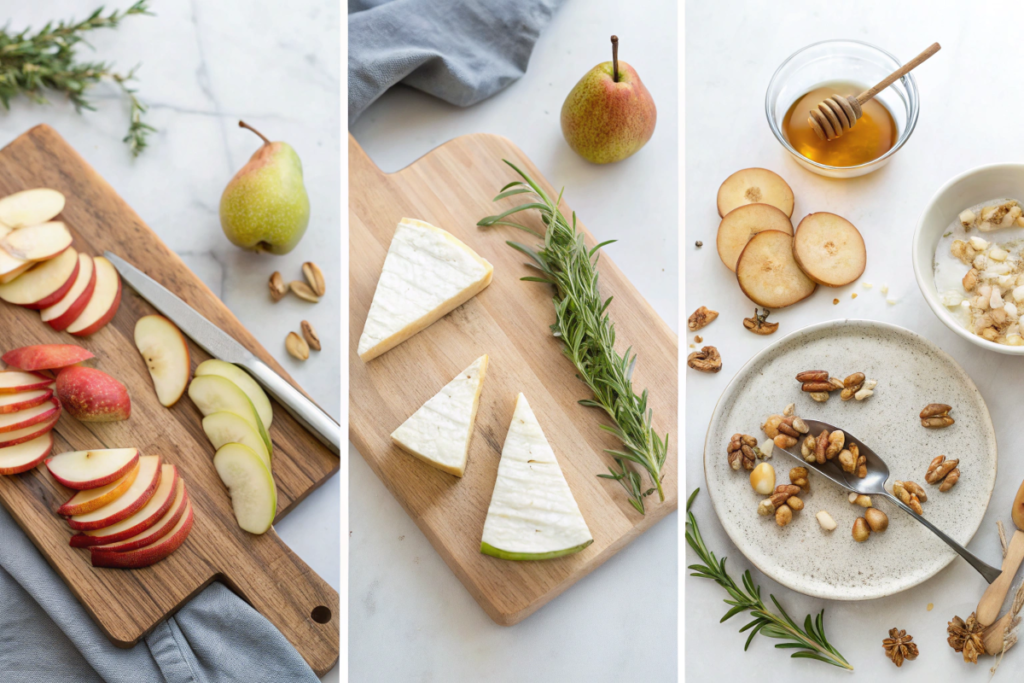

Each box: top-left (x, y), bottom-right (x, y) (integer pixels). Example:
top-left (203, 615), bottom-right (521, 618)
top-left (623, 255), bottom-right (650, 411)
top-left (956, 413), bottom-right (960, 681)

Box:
top-left (684, 0), bottom-right (1024, 683)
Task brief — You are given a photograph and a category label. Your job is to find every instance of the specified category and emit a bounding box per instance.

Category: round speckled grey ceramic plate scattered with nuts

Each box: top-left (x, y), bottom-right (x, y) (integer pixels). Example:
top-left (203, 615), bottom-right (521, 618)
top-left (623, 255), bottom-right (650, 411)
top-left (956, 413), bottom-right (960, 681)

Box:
top-left (705, 321), bottom-right (997, 600)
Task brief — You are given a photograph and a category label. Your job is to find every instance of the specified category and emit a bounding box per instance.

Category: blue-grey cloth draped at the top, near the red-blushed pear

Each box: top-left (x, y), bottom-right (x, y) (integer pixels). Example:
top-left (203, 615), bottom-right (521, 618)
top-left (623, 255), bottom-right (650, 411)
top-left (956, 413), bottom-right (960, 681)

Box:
top-left (348, 0), bottom-right (562, 125)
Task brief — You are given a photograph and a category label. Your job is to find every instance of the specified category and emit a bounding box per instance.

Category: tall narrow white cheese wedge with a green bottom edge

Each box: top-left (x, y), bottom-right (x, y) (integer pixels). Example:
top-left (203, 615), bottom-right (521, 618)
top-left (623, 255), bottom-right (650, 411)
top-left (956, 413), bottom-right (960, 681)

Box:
top-left (480, 393), bottom-right (594, 560)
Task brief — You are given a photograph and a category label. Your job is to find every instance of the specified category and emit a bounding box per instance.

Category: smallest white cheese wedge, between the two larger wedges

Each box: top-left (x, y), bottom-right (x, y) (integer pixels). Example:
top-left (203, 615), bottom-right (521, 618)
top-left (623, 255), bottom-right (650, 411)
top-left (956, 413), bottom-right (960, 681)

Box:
top-left (391, 355), bottom-right (487, 477)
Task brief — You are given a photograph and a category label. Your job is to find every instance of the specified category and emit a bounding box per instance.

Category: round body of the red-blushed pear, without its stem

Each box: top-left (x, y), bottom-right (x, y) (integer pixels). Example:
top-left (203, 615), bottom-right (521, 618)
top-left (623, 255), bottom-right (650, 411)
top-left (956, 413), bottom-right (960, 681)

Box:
top-left (561, 60), bottom-right (657, 164)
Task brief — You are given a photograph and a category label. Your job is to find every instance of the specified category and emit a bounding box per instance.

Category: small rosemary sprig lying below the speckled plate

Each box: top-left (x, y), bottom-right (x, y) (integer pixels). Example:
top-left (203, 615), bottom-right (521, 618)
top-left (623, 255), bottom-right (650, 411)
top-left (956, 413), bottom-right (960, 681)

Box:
top-left (686, 488), bottom-right (853, 671)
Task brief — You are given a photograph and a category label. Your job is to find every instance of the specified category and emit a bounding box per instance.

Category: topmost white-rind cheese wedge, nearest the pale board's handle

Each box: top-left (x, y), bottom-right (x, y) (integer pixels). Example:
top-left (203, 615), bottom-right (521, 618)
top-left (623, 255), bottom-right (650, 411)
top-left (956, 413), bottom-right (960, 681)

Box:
top-left (358, 218), bottom-right (494, 361)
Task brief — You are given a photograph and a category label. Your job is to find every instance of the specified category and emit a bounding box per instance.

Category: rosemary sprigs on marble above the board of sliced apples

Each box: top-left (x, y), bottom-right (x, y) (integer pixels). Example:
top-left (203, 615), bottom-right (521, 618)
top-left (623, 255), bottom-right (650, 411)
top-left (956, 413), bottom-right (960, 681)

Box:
top-left (0, 0), bottom-right (155, 156)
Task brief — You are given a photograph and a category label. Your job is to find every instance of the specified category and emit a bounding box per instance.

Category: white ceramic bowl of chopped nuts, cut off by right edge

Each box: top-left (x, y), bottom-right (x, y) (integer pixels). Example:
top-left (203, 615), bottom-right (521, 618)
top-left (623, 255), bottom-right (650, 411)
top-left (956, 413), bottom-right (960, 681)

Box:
top-left (913, 164), bottom-right (1024, 355)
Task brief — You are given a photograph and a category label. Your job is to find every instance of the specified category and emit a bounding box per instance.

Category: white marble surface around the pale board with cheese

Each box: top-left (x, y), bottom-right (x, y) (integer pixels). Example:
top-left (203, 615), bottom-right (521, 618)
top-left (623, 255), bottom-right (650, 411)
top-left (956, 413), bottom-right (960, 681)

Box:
top-left (349, 0), bottom-right (678, 683)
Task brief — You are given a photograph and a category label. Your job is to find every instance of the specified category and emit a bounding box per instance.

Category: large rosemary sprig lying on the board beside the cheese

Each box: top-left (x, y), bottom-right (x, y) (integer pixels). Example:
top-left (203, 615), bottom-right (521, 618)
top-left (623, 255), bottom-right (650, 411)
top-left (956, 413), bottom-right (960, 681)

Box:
top-left (477, 160), bottom-right (669, 514)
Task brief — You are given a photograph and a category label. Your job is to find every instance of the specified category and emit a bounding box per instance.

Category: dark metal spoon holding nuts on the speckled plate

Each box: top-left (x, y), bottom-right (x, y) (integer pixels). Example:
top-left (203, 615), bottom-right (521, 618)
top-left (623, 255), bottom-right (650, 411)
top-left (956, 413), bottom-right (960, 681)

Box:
top-left (775, 419), bottom-right (1001, 584)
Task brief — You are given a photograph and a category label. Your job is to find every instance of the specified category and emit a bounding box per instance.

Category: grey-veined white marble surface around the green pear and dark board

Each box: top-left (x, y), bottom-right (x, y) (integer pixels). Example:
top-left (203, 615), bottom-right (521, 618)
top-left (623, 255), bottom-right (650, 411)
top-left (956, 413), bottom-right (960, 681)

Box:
top-left (0, 0), bottom-right (343, 680)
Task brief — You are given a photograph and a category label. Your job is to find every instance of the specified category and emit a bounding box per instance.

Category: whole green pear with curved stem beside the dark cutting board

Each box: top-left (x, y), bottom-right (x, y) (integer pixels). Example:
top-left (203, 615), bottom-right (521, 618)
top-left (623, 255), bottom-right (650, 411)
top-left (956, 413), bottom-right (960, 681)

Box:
top-left (220, 121), bottom-right (309, 255)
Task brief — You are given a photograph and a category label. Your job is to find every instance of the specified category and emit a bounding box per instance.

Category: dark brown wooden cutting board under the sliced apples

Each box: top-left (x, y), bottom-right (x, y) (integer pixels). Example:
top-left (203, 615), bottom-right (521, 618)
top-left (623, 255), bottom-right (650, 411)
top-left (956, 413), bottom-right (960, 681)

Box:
top-left (0, 126), bottom-right (341, 675)
